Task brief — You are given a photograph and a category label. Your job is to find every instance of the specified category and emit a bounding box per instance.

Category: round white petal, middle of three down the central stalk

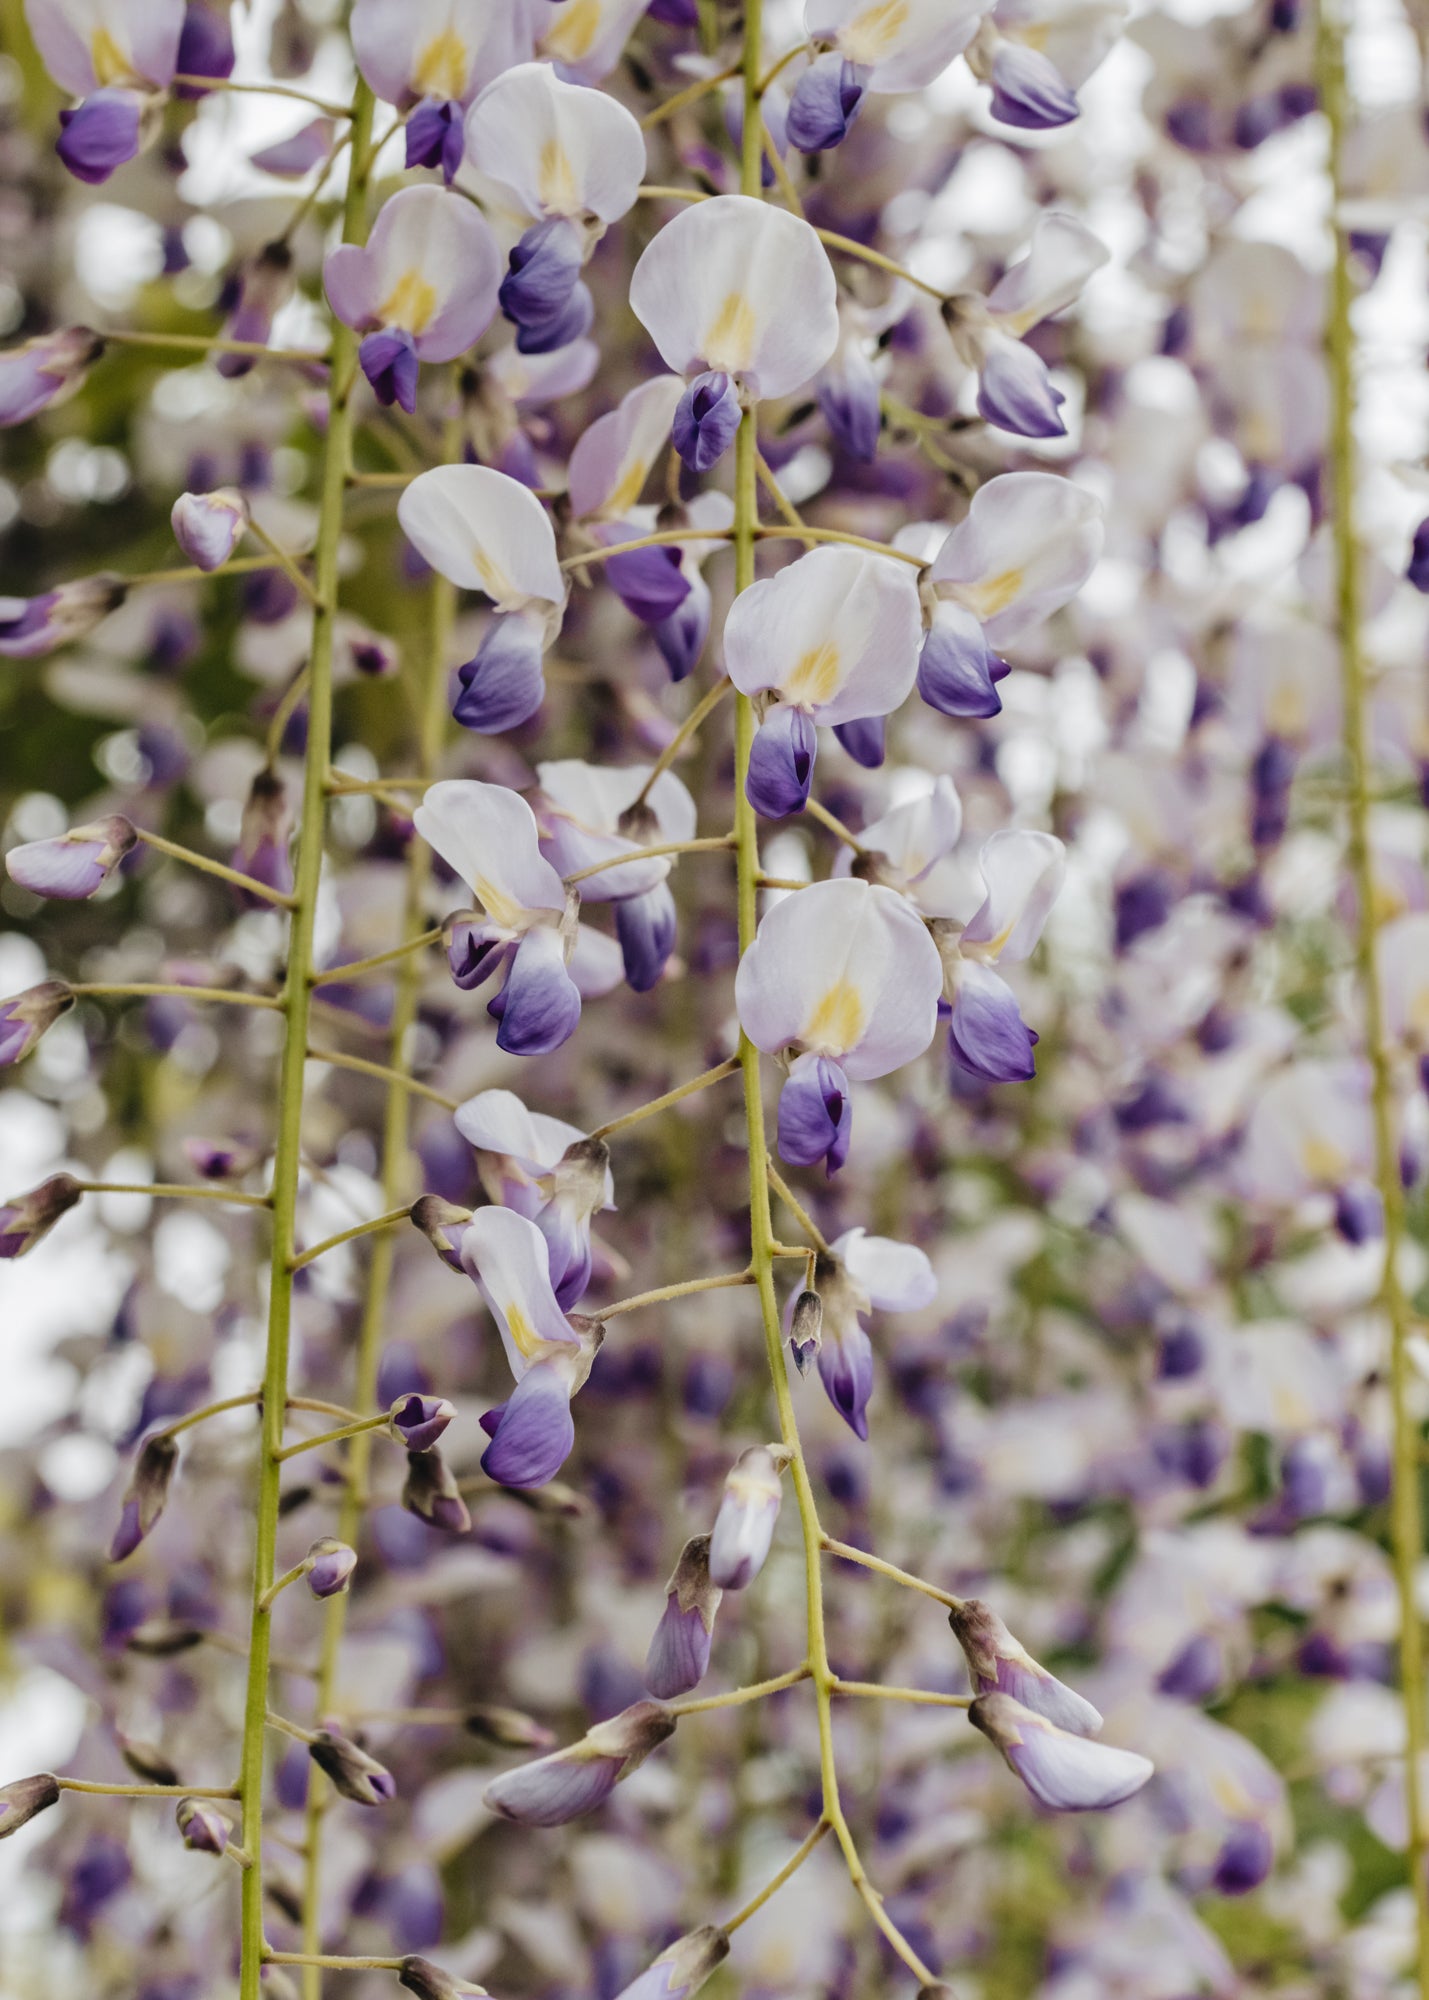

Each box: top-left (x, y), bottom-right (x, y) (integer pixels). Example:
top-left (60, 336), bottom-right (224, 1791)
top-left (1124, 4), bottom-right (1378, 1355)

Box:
top-left (725, 546), bottom-right (923, 724)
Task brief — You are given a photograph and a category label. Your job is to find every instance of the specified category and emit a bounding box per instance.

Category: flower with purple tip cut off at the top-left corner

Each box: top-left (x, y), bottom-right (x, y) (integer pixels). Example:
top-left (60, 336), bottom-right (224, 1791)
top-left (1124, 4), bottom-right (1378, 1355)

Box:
top-left (24, 0), bottom-right (184, 186)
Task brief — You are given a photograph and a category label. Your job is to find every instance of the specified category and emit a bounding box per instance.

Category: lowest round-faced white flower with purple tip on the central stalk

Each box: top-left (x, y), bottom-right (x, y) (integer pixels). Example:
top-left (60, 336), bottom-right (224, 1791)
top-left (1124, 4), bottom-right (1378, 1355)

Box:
top-left (735, 880), bottom-right (943, 1174)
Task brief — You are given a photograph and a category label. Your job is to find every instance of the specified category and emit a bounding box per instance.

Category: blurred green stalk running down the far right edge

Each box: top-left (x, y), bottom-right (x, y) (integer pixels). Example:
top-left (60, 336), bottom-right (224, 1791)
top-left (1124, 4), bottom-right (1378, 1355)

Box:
top-left (1315, 0), bottom-right (1429, 2000)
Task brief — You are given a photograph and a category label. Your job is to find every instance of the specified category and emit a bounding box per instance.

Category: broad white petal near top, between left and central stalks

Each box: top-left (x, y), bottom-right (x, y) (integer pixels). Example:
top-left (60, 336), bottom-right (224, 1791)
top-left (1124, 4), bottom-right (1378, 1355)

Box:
top-left (466, 62), bottom-right (644, 222)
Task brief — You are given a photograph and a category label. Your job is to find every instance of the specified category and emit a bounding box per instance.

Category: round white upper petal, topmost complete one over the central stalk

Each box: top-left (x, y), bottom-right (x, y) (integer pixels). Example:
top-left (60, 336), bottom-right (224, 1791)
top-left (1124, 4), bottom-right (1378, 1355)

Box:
top-left (630, 194), bottom-right (839, 396)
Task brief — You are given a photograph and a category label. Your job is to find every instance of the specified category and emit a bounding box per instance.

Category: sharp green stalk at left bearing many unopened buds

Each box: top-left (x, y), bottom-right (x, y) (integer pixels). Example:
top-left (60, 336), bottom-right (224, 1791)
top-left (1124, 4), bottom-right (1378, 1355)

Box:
top-left (238, 82), bottom-right (372, 2000)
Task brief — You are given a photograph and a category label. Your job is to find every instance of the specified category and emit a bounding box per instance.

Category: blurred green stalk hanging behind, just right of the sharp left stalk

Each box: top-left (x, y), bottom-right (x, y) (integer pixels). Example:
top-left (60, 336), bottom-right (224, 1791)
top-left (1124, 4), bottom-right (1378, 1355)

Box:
top-left (302, 410), bottom-right (458, 2000)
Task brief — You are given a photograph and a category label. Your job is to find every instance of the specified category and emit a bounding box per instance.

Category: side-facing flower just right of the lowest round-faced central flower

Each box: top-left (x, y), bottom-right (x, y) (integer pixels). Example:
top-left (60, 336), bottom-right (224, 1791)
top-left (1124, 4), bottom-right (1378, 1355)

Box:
top-left (933, 826), bottom-right (1067, 1084)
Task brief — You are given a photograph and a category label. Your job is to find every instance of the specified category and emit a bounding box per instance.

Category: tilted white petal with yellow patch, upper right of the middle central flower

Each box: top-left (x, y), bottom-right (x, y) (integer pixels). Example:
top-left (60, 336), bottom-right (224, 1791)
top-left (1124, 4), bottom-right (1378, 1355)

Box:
top-left (929, 472), bottom-right (1107, 646)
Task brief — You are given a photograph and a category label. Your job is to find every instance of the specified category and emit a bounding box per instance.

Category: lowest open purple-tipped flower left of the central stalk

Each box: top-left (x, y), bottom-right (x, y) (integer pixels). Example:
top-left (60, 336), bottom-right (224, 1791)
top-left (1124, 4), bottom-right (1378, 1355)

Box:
top-left (462, 1208), bottom-right (602, 1488)
